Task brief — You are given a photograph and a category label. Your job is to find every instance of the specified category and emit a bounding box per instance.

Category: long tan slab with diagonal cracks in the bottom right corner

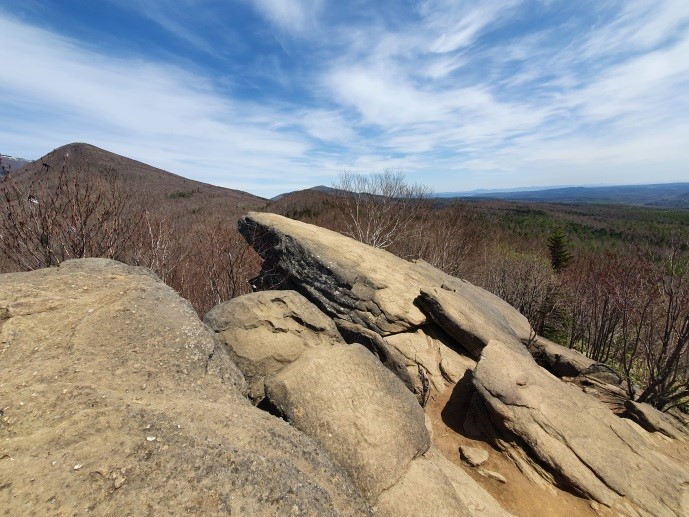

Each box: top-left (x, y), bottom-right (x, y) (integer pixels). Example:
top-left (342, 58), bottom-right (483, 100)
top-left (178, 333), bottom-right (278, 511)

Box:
top-left (474, 341), bottom-right (689, 515)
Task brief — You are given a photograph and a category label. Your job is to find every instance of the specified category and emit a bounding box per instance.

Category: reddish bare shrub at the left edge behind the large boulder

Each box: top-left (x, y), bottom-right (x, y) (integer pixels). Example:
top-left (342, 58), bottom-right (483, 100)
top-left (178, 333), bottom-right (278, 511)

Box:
top-left (0, 163), bottom-right (144, 270)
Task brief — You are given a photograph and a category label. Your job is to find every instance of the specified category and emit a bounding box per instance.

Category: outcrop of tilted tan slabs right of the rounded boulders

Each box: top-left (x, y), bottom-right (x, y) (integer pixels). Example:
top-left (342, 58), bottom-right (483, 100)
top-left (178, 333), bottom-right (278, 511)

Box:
top-left (239, 214), bottom-right (689, 515)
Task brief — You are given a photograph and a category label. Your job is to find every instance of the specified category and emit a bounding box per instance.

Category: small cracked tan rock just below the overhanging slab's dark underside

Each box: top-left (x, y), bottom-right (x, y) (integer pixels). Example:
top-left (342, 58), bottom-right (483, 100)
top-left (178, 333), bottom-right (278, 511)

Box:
top-left (204, 291), bottom-right (344, 402)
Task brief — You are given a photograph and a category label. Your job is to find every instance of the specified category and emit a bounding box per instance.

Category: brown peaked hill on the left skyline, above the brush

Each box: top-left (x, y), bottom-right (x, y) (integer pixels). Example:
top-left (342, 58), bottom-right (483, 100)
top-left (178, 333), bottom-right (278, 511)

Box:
top-left (7, 143), bottom-right (267, 219)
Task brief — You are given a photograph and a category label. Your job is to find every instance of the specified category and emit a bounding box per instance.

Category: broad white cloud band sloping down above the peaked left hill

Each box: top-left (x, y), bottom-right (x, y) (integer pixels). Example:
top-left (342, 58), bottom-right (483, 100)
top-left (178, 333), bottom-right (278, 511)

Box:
top-left (0, 14), bottom-right (322, 193)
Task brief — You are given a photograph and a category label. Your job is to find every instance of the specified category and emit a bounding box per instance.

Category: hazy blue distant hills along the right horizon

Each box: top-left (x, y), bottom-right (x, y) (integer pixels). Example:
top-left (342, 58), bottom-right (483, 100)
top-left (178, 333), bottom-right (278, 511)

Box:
top-left (442, 183), bottom-right (689, 209)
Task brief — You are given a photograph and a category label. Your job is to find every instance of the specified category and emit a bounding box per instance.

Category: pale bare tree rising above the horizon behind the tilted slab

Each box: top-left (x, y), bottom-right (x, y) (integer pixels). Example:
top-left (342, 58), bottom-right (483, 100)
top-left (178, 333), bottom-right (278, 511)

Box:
top-left (334, 170), bottom-right (429, 249)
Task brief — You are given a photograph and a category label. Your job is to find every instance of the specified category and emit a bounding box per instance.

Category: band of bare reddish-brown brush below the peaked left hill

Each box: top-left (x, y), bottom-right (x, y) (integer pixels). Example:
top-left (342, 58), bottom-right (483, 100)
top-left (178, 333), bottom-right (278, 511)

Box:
top-left (0, 159), bottom-right (261, 315)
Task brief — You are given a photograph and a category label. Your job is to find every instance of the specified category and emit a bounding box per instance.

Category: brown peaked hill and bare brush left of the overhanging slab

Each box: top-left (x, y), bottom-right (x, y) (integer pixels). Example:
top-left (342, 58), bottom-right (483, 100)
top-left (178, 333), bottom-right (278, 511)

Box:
top-left (0, 144), bottom-right (265, 315)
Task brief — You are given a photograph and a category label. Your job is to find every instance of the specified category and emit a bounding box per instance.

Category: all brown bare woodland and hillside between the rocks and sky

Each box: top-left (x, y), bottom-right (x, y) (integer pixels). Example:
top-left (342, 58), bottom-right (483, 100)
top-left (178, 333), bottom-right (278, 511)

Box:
top-left (0, 148), bottom-right (689, 409)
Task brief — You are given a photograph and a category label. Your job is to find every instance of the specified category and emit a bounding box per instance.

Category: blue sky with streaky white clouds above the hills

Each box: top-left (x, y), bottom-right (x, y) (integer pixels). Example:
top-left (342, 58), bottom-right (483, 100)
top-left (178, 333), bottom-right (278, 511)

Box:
top-left (0, 0), bottom-right (689, 196)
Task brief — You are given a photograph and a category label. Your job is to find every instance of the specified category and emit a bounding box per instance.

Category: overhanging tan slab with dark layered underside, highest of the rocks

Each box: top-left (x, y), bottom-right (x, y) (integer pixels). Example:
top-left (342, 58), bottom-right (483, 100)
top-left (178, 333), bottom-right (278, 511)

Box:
top-left (239, 212), bottom-right (530, 339)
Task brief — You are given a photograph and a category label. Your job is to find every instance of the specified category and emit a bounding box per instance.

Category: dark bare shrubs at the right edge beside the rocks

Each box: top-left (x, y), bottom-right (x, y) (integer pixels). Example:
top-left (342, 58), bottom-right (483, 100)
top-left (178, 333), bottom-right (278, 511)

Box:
top-left (560, 243), bottom-right (689, 410)
